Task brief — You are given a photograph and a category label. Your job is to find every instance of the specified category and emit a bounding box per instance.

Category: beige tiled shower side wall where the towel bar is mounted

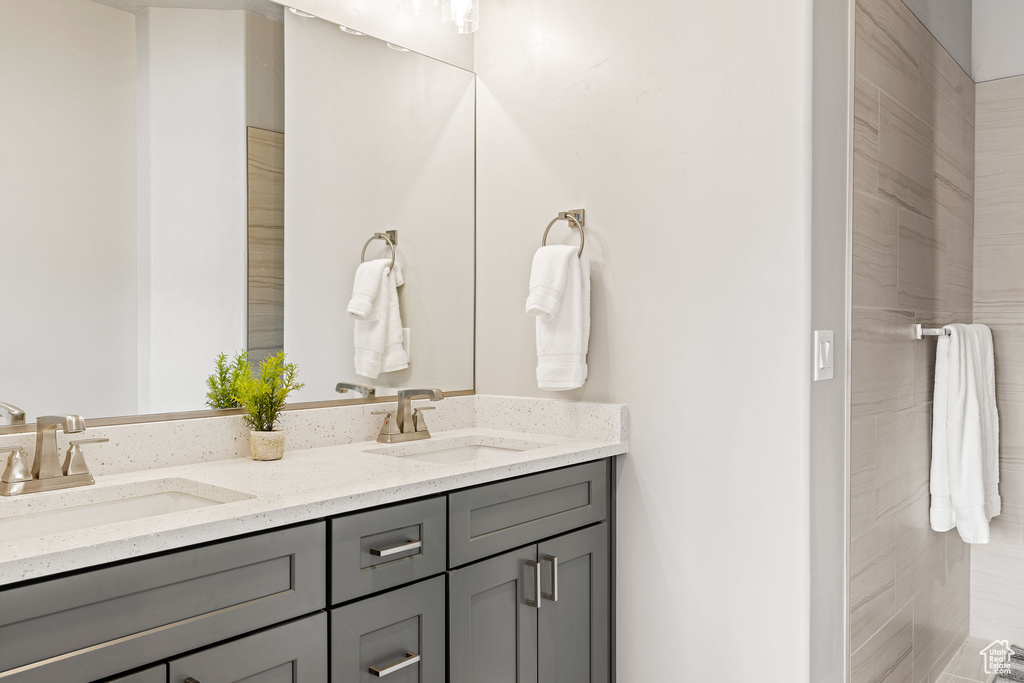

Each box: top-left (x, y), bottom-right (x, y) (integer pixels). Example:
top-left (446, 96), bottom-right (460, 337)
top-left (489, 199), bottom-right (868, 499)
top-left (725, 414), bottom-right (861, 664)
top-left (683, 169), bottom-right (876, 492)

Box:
top-left (850, 0), bottom-right (975, 683)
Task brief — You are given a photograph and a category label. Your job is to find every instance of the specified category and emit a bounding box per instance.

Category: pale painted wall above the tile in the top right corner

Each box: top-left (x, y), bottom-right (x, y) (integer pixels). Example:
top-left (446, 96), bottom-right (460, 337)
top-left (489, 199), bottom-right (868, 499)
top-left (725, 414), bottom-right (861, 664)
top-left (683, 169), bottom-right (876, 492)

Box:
top-left (972, 0), bottom-right (1024, 83)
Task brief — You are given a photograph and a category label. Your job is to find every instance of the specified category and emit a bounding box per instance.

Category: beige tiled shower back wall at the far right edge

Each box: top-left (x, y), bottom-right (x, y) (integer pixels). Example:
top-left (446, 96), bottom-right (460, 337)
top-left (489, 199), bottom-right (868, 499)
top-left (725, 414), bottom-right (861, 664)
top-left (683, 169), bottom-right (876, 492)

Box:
top-left (971, 77), bottom-right (1024, 644)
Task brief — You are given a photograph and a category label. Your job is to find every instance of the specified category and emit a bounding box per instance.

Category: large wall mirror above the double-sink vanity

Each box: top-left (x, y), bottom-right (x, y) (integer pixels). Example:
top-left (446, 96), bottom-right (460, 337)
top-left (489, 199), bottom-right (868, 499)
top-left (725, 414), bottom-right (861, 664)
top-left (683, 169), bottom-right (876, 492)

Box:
top-left (0, 0), bottom-right (474, 425)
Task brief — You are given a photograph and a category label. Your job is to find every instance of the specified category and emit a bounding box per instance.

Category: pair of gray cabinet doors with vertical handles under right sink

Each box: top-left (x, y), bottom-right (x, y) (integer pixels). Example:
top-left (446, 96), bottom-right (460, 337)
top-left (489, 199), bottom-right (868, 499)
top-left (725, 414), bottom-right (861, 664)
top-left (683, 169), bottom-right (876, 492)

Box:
top-left (449, 523), bottom-right (610, 683)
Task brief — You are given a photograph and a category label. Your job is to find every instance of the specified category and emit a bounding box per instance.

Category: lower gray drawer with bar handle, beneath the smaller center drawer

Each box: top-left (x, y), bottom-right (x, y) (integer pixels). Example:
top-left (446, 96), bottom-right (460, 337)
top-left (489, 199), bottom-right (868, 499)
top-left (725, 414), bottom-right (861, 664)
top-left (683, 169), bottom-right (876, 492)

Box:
top-left (331, 577), bottom-right (445, 683)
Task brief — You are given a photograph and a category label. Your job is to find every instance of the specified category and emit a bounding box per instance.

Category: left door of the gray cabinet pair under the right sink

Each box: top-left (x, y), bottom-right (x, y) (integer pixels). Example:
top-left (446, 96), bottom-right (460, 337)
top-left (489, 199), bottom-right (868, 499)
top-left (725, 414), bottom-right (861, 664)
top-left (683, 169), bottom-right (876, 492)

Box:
top-left (449, 546), bottom-right (540, 683)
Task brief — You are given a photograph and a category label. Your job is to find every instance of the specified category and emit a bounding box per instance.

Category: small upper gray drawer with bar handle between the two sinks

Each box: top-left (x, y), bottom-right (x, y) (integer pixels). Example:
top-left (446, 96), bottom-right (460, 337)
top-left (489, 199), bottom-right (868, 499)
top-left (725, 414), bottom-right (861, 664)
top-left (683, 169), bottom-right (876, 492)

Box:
top-left (331, 497), bottom-right (446, 605)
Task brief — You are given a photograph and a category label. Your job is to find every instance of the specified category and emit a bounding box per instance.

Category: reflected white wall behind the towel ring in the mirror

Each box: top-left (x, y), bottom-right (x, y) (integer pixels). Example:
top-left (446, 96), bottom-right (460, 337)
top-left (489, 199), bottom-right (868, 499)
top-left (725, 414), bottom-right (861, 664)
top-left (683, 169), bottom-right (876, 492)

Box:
top-left (285, 12), bottom-right (474, 400)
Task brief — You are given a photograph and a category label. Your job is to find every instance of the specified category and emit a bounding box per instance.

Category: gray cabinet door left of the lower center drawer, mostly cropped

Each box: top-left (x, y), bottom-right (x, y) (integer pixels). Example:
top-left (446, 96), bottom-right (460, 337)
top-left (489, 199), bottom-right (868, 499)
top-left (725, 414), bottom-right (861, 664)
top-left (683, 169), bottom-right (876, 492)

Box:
top-left (170, 612), bottom-right (327, 683)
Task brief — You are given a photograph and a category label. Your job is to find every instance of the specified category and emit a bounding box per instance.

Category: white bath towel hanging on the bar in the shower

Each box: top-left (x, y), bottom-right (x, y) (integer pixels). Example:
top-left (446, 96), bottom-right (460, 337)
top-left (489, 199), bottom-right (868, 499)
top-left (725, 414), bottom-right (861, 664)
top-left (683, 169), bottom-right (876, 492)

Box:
top-left (930, 325), bottom-right (1000, 543)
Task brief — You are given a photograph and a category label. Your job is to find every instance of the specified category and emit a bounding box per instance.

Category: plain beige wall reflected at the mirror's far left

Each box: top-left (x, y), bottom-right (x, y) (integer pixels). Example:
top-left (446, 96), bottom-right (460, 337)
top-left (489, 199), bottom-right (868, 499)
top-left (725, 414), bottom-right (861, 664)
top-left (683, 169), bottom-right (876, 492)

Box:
top-left (0, 0), bottom-right (137, 421)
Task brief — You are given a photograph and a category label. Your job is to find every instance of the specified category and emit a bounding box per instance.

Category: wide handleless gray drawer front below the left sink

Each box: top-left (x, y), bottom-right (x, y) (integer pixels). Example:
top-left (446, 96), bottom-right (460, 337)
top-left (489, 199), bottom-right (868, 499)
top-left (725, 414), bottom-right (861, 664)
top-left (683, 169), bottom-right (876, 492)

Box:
top-left (0, 522), bottom-right (327, 683)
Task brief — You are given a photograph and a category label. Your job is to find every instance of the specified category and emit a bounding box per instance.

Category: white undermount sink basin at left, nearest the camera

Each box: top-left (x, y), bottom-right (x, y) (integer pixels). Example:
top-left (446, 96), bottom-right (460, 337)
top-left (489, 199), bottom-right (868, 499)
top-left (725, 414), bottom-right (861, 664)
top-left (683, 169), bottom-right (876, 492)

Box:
top-left (0, 479), bottom-right (252, 544)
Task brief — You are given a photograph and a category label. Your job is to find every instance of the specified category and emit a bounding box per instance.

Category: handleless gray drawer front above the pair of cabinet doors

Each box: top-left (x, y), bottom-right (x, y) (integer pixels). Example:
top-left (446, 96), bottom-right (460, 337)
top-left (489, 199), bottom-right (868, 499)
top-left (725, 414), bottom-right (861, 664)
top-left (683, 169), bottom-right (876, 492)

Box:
top-left (449, 460), bottom-right (608, 567)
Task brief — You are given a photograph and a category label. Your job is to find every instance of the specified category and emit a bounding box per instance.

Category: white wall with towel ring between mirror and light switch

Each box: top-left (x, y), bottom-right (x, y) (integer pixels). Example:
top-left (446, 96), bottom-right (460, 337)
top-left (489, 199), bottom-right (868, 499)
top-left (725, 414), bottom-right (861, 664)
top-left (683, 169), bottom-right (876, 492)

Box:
top-left (476, 0), bottom-right (811, 683)
